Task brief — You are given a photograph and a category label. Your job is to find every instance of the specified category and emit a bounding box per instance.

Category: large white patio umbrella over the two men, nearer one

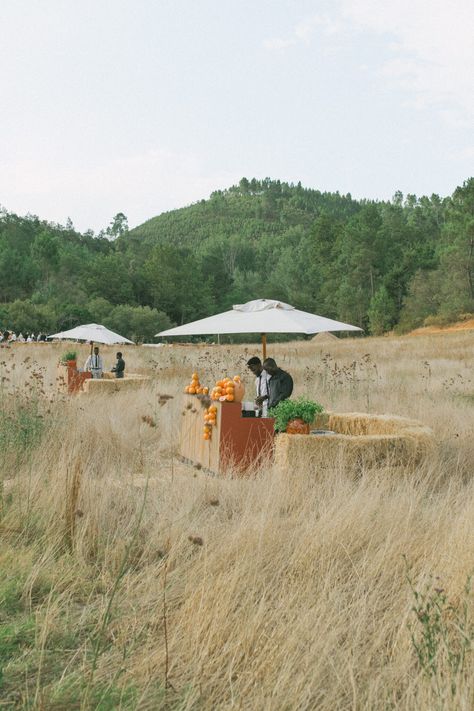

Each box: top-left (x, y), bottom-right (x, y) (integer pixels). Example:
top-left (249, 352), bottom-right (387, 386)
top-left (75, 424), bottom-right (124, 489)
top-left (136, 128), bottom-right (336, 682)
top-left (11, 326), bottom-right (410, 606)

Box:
top-left (156, 299), bottom-right (362, 358)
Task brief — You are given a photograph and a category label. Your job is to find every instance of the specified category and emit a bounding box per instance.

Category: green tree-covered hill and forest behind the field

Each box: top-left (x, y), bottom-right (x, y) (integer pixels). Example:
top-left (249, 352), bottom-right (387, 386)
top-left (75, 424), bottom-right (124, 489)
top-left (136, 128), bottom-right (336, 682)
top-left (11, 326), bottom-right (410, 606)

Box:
top-left (0, 178), bottom-right (474, 340)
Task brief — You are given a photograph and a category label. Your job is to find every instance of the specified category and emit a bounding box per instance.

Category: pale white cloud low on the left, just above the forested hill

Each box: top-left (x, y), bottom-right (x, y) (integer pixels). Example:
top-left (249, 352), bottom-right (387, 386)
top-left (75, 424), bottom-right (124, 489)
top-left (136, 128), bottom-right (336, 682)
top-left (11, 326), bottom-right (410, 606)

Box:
top-left (0, 149), bottom-right (242, 231)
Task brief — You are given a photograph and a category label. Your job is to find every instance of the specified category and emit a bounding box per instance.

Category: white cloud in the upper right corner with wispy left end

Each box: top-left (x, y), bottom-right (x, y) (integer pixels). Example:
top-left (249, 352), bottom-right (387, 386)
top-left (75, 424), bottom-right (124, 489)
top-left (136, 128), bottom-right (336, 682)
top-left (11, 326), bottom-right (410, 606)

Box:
top-left (263, 0), bottom-right (474, 128)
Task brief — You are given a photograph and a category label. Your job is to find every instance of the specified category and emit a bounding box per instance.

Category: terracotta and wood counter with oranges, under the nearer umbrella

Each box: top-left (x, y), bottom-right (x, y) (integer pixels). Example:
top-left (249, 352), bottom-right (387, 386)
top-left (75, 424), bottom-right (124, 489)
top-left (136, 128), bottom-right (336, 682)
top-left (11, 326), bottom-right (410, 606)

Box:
top-left (179, 395), bottom-right (274, 476)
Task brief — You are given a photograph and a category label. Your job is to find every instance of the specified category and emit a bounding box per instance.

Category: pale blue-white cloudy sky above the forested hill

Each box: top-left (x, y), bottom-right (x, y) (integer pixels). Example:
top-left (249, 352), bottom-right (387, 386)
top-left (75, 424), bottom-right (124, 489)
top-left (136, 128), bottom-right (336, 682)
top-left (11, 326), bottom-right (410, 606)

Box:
top-left (0, 0), bottom-right (474, 232)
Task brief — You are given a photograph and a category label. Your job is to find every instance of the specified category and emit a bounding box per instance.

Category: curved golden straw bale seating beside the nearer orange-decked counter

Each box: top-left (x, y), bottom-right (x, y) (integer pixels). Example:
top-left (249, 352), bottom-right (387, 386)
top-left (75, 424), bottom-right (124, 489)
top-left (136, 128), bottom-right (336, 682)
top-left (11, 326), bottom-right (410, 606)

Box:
top-left (275, 413), bottom-right (436, 472)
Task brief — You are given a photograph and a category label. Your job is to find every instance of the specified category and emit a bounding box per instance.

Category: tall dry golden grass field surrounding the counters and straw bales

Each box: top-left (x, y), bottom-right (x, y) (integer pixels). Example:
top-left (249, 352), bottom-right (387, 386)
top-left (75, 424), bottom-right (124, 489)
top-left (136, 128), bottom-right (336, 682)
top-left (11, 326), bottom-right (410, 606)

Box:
top-left (0, 332), bottom-right (474, 711)
